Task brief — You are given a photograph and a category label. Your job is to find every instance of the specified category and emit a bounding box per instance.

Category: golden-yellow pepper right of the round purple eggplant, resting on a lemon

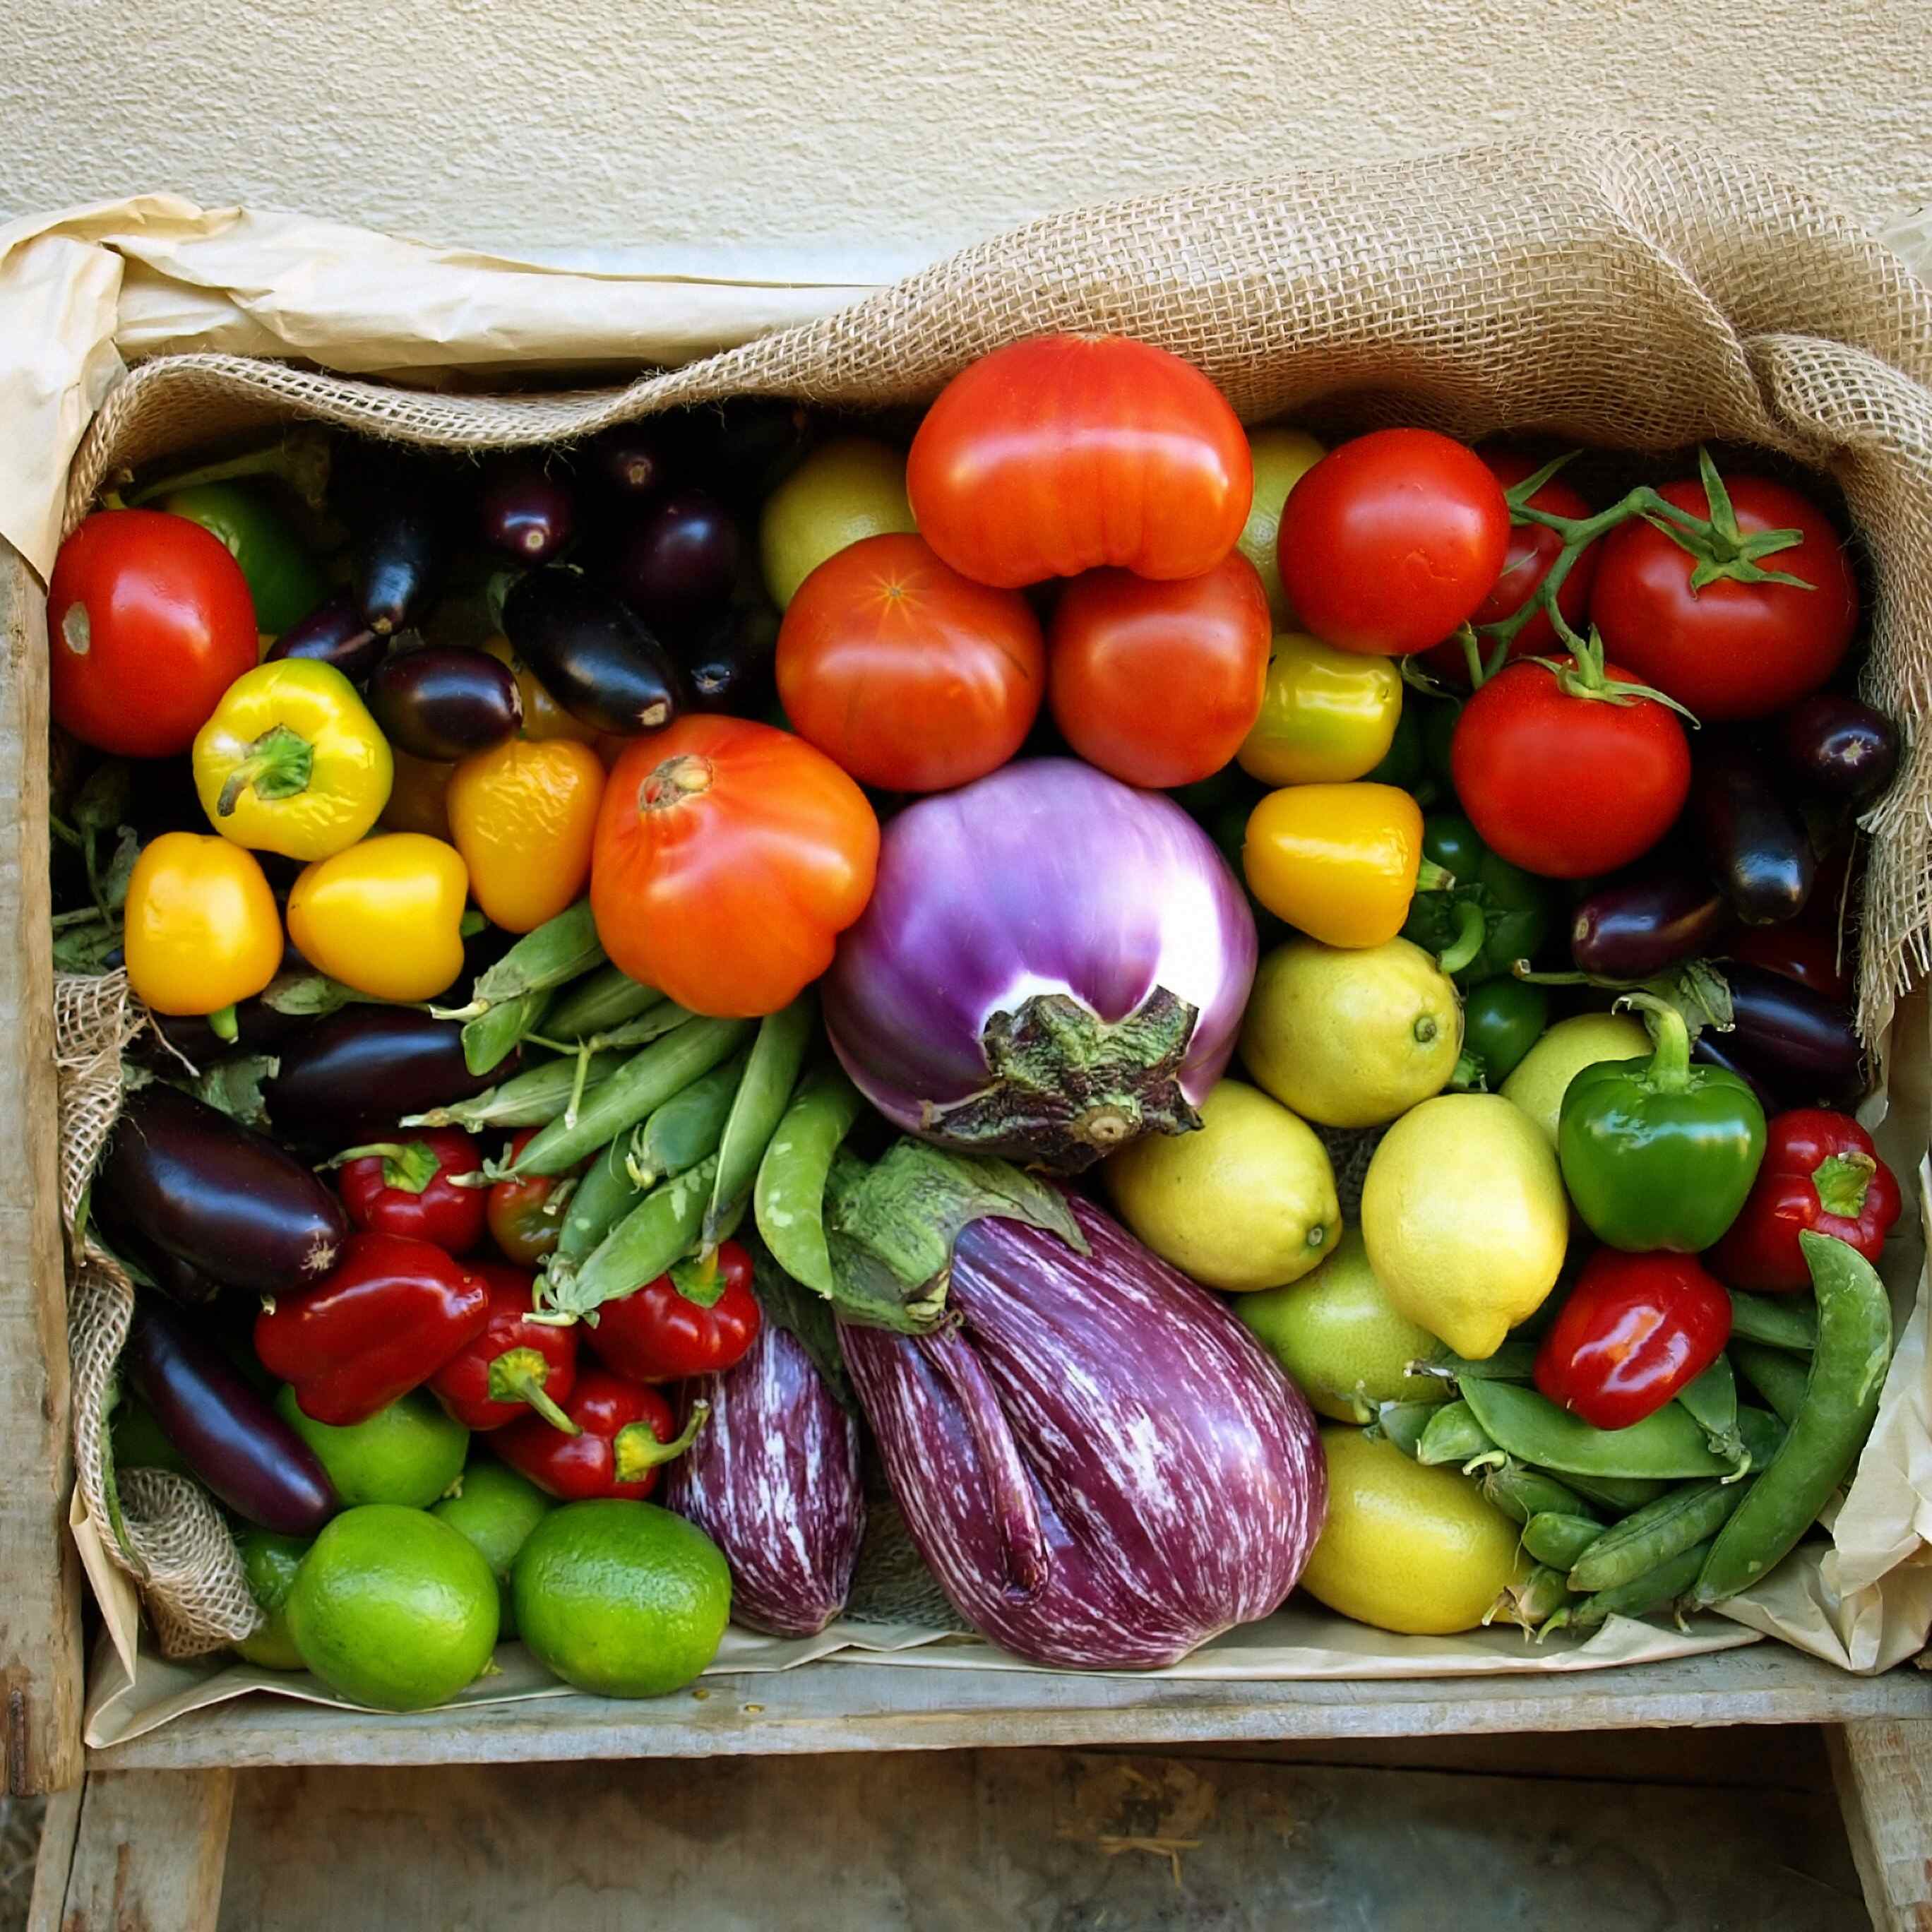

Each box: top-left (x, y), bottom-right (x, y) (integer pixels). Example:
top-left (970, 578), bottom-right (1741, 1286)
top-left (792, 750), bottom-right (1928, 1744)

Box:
top-left (1241, 785), bottom-right (1449, 947)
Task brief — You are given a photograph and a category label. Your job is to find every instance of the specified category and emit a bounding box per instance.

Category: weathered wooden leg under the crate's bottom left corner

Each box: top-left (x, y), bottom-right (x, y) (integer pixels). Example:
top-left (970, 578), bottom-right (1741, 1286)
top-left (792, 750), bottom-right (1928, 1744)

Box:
top-left (27, 1772), bottom-right (236, 1932)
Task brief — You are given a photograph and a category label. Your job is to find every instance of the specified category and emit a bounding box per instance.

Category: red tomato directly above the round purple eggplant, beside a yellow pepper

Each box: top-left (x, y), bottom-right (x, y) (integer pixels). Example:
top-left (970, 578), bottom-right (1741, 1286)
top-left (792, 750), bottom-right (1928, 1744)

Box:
top-left (1047, 551), bottom-right (1273, 790)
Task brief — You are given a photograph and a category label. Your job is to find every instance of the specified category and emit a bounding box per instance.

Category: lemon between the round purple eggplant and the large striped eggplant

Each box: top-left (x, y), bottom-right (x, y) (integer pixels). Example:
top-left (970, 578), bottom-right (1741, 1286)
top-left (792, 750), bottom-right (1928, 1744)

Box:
top-left (1105, 1080), bottom-right (1341, 1294)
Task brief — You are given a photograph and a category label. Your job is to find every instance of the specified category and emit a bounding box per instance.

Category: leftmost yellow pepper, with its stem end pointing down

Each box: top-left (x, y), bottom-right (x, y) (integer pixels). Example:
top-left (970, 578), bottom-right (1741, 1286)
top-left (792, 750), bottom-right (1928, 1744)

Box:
top-left (121, 833), bottom-right (282, 1013)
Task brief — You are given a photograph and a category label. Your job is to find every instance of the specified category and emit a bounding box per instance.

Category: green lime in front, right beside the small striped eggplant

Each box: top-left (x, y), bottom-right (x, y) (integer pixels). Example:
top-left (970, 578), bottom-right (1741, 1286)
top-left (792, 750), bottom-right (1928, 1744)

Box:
top-left (510, 1497), bottom-right (730, 1696)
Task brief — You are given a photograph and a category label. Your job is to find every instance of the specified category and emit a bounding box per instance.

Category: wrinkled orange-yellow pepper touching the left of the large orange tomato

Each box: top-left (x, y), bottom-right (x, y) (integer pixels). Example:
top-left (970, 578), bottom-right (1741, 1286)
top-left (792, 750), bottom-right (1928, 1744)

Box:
top-left (450, 738), bottom-right (604, 933)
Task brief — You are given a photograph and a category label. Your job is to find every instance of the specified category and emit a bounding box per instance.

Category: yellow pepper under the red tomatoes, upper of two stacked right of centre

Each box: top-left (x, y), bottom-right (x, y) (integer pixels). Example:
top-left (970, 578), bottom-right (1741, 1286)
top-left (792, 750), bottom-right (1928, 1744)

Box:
top-left (1234, 630), bottom-right (1402, 785)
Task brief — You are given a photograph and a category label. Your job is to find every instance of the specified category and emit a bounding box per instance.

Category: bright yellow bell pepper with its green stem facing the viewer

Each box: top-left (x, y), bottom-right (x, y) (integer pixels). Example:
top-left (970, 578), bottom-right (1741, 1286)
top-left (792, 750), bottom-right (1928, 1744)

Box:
top-left (195, 657), bottom-right (394, 860)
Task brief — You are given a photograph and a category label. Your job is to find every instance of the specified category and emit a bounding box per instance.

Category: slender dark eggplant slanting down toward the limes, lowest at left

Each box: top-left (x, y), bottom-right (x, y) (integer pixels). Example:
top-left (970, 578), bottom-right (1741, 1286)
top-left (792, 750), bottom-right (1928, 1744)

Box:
top-left (120, 1299), bottom-right (342, 1536)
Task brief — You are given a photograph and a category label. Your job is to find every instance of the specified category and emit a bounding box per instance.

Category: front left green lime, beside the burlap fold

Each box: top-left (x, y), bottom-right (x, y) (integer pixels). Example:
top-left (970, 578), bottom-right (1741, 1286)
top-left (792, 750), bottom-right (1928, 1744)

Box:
top-left (286, 1503), bottom-right (496, 1710)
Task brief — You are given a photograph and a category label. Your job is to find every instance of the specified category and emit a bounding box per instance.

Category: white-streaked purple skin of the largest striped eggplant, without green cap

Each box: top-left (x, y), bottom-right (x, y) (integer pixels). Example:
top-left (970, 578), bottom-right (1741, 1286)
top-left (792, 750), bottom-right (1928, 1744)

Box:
top-left (840, 1198), bottom-right (1328, 1669)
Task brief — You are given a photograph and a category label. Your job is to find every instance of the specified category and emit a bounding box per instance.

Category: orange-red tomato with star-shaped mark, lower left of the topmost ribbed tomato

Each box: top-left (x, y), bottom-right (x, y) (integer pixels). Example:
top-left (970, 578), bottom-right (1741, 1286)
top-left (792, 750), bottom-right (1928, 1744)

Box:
top-left (779, 535), bottom-right (1047, 792)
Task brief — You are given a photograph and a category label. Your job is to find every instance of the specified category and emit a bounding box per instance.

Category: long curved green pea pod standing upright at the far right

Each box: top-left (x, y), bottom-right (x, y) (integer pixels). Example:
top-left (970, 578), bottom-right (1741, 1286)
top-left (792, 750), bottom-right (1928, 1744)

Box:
top-left (1694, 1229), bottom-right (1892, 1606)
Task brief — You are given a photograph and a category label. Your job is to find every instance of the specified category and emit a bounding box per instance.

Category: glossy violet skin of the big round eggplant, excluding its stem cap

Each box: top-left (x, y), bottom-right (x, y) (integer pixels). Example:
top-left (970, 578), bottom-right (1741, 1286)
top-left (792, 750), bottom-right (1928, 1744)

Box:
top-left (823, 758), bottom-right (1256, 1138)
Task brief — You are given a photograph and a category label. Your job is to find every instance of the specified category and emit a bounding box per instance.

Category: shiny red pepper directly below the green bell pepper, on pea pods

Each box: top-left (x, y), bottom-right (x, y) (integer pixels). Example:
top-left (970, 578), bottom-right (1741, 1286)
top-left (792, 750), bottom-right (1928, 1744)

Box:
top-left (1536, 1248), bottom-right (1731, 1430)
